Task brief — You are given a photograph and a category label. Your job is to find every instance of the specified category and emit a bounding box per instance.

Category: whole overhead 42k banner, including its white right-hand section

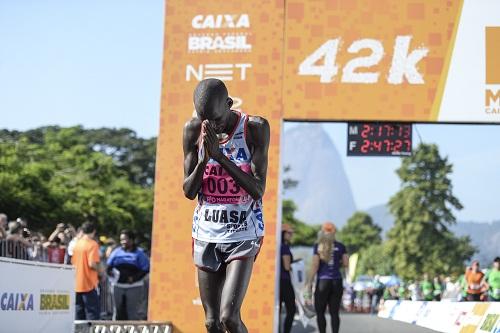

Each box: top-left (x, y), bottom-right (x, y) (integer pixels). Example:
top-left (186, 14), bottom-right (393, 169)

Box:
top-left (283, 0), bottom-right (500, 123)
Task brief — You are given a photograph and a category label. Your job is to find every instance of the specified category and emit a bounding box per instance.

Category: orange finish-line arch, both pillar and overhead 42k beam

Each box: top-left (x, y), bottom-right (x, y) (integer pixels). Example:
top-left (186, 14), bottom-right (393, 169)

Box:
top-left (149, 0), bottom-right (500, 332)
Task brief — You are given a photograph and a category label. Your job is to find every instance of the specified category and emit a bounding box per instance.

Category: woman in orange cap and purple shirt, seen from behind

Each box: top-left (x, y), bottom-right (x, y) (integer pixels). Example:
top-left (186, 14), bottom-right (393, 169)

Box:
top-left (307, 222), bottom-right (349, 333)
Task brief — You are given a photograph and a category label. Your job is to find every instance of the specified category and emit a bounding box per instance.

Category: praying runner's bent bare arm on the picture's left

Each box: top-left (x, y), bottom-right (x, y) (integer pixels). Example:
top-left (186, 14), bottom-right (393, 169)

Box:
top-left (182, 118), bottom-right (208, 200)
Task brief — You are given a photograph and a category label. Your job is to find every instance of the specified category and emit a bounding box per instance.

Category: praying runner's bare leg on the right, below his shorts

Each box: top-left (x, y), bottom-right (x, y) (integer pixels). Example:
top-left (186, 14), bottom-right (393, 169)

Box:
top-left (221, 257), bottom-right (254, 333)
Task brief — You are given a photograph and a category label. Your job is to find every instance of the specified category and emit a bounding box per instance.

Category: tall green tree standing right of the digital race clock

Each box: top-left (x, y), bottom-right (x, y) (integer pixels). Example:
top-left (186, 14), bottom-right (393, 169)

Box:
top-left (387, 144), bottom-right (475, 279)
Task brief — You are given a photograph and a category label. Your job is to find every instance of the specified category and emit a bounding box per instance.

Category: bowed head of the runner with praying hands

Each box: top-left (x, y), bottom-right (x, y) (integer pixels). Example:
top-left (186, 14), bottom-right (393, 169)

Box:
top-left (193, 79), bottom-right (233, 133)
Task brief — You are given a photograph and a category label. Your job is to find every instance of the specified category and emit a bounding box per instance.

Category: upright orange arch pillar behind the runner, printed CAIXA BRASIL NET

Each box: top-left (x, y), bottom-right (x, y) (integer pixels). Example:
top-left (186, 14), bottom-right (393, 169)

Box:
top-left (149, 0), bottom-right (284, 332)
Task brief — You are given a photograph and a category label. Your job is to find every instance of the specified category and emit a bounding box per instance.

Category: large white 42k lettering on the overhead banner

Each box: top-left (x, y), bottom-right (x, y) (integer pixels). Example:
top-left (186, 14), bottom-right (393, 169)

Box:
top-left (299, 36), bottom-right (429, 84)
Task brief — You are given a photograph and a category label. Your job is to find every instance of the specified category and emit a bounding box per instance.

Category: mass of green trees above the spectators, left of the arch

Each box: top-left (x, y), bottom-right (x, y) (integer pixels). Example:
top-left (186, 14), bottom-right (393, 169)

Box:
top-left (0, 127), bottom-right (156, 234)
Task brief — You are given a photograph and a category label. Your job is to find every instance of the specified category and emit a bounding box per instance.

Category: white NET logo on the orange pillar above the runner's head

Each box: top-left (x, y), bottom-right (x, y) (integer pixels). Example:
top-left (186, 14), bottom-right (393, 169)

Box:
top-left (186, 64), bottom-right (252, 81)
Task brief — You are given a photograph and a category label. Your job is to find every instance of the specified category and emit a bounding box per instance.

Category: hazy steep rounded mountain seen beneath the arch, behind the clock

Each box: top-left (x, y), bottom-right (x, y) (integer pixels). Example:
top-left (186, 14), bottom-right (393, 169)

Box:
top-left (282, 124), bottom-right (356, 227)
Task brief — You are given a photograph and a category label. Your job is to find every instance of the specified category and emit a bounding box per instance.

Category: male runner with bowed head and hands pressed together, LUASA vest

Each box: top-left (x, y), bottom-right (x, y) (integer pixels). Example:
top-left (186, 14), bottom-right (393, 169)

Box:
top-left (183, 79), bottom-right (269, 333)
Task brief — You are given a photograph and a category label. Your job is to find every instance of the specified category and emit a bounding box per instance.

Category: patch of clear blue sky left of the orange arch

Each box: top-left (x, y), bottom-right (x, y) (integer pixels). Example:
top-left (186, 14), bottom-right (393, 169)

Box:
top-left (0, 0), bottom-right (164, 137)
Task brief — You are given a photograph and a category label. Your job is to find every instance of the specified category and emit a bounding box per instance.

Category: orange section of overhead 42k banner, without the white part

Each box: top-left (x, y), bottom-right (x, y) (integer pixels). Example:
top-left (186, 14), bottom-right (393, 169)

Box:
top-left (283, 0), bottom-right (460, 121)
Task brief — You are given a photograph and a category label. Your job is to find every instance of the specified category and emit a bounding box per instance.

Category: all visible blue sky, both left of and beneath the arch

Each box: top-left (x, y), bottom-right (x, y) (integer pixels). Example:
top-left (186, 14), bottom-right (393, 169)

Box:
top-left (0, 0), bottom-right (500, 222)
